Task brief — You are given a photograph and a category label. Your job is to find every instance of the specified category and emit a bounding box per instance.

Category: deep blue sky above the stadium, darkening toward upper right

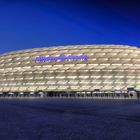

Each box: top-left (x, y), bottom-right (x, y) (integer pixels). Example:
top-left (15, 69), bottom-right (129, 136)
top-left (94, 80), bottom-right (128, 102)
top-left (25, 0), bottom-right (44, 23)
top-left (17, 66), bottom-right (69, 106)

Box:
top-left (0, 0), bottom-right (140, 53)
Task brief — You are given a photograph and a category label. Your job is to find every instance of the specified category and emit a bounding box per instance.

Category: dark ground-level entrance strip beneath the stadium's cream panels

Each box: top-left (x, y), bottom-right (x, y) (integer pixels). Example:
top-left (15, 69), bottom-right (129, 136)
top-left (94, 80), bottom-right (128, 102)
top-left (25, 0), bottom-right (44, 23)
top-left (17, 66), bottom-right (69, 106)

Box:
top-left (0, 90), bottom-right (140, 99)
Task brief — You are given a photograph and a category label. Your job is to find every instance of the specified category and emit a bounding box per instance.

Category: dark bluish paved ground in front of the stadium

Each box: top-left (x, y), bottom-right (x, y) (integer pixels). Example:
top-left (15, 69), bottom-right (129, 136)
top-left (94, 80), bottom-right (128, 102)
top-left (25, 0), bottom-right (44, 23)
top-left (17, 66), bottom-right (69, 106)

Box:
top-left (0, 98), bottom-right (140, 140)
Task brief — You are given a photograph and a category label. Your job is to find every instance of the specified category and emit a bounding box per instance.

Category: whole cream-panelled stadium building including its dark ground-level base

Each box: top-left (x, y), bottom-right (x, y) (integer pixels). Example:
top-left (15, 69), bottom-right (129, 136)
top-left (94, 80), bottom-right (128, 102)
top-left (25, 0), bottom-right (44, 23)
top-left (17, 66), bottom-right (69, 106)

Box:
top-left (0, 45), bottom-right (140, 98)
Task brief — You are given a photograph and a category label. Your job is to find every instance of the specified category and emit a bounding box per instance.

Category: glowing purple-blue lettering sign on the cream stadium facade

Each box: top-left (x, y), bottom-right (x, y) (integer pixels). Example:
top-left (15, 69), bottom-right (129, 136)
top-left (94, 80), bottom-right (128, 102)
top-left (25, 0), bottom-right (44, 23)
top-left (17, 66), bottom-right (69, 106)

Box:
top-left (34, 54), bottom-right (88, 63)
